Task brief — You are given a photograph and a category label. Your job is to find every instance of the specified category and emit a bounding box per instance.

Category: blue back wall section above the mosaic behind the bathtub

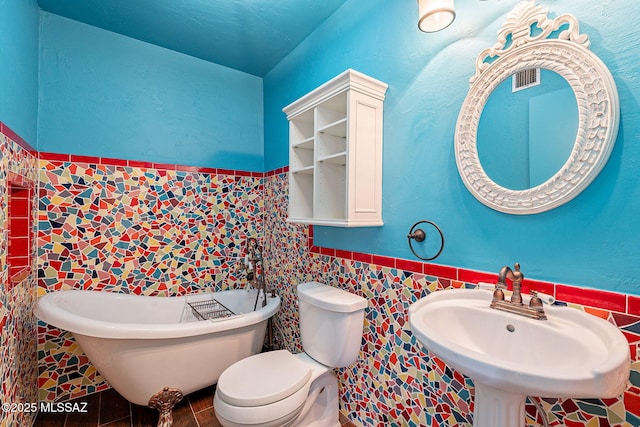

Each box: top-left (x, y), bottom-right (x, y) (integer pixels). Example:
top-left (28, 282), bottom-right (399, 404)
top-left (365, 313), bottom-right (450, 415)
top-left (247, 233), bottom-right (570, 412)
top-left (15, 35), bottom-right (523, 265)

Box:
top-left (37, 12), bottom-right (264, 171)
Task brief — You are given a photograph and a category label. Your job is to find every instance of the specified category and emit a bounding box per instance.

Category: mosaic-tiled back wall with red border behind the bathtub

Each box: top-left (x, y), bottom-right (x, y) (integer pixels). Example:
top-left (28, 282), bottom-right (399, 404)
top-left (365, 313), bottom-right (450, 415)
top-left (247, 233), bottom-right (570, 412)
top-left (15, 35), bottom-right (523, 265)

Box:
top-left (38, 154), bottom-right (264, 401)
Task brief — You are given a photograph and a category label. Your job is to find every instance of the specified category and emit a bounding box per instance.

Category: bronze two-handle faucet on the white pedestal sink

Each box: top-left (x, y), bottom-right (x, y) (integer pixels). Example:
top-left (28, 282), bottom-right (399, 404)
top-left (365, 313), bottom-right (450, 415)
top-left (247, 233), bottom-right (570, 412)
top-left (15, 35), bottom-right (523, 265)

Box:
top-left (490, 263), bottom-right (547, 320)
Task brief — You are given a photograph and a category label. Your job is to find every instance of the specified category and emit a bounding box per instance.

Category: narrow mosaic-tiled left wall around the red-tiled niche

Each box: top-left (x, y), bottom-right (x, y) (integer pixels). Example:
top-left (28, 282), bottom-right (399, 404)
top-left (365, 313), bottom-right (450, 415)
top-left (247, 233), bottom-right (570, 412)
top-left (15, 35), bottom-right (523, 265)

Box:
top-left (0, 123), bottom-right (38, 426)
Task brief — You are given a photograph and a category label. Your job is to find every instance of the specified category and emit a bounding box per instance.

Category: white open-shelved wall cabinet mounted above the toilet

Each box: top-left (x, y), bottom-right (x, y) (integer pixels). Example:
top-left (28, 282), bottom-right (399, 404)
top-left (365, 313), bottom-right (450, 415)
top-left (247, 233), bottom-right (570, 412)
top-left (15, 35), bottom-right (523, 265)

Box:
top-left (283, 69), bottom-right (387, 227)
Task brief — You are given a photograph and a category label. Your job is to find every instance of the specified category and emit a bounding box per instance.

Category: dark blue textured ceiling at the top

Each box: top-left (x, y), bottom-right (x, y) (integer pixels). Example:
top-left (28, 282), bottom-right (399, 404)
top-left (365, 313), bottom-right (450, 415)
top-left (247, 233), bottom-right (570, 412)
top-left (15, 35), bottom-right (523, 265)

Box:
top-left (38, 0), bottom-right (346, 76)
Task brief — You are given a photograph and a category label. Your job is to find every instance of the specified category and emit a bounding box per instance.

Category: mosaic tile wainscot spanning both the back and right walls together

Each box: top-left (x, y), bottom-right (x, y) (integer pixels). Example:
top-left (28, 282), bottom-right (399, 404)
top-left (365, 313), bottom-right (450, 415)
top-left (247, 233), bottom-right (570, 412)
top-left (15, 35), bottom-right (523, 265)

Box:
top-left (38, 155), bottom-right (640, 427)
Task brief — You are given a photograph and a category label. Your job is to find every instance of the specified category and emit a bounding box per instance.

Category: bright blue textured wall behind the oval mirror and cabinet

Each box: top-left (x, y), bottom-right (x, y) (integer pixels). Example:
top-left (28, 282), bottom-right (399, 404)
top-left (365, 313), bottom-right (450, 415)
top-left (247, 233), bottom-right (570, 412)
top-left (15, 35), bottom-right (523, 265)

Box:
top-left (264, 0), bottom-right (640, 294)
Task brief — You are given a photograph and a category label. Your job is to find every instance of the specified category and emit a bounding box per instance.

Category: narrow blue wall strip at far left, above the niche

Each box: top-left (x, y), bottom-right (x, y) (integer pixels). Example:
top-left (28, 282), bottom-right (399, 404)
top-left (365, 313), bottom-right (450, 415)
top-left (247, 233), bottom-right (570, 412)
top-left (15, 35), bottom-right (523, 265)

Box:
top-left (0, 0), bottom-right (38, 148)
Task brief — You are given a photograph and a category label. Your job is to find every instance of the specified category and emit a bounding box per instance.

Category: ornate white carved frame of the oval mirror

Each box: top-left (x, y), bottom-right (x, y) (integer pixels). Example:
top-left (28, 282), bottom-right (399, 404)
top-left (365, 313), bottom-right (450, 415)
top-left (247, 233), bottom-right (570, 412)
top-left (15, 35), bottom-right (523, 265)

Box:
top-left (454, 1), bottom-right (620, 215)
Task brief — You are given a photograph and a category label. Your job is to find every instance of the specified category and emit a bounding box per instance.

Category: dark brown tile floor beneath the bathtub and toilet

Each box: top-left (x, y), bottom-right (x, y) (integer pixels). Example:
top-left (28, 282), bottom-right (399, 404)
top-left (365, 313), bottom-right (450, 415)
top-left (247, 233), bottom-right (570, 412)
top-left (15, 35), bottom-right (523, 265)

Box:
top-left (34, 386), bottom-right (355, 427)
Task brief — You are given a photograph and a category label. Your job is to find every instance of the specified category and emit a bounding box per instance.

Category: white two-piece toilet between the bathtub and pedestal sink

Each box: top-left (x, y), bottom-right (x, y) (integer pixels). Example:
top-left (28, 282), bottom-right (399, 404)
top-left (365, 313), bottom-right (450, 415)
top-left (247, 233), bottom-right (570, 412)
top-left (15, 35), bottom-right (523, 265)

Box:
top-left (214, 282), bottom-right (367, 427)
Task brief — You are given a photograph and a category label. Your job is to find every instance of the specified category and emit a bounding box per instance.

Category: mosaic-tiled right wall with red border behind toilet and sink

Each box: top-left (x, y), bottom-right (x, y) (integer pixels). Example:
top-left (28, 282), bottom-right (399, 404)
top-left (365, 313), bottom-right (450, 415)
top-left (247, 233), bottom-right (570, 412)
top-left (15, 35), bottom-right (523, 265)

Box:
top-left (264, 173), bottom-right (640, 427)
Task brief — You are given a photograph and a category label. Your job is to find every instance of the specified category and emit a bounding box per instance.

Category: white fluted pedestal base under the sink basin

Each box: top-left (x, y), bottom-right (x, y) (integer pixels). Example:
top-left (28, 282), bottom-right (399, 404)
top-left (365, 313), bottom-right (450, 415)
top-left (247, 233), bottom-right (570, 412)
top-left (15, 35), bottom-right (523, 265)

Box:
top-left (473, 382), bottom-right (527, 427)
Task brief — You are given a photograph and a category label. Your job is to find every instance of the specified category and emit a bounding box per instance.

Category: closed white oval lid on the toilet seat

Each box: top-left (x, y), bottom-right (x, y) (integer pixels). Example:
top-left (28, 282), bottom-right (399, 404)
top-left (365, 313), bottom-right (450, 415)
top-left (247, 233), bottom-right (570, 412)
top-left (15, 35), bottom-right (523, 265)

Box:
top-left (216, 350), bottom-right (311, 406)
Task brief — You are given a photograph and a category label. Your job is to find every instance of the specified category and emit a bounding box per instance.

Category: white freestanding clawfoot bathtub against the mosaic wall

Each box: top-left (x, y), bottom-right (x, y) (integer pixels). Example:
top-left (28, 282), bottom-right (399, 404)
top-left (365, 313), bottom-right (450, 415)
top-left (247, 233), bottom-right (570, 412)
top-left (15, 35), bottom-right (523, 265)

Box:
top-left (34, 289), bottom-right (280, 409)
